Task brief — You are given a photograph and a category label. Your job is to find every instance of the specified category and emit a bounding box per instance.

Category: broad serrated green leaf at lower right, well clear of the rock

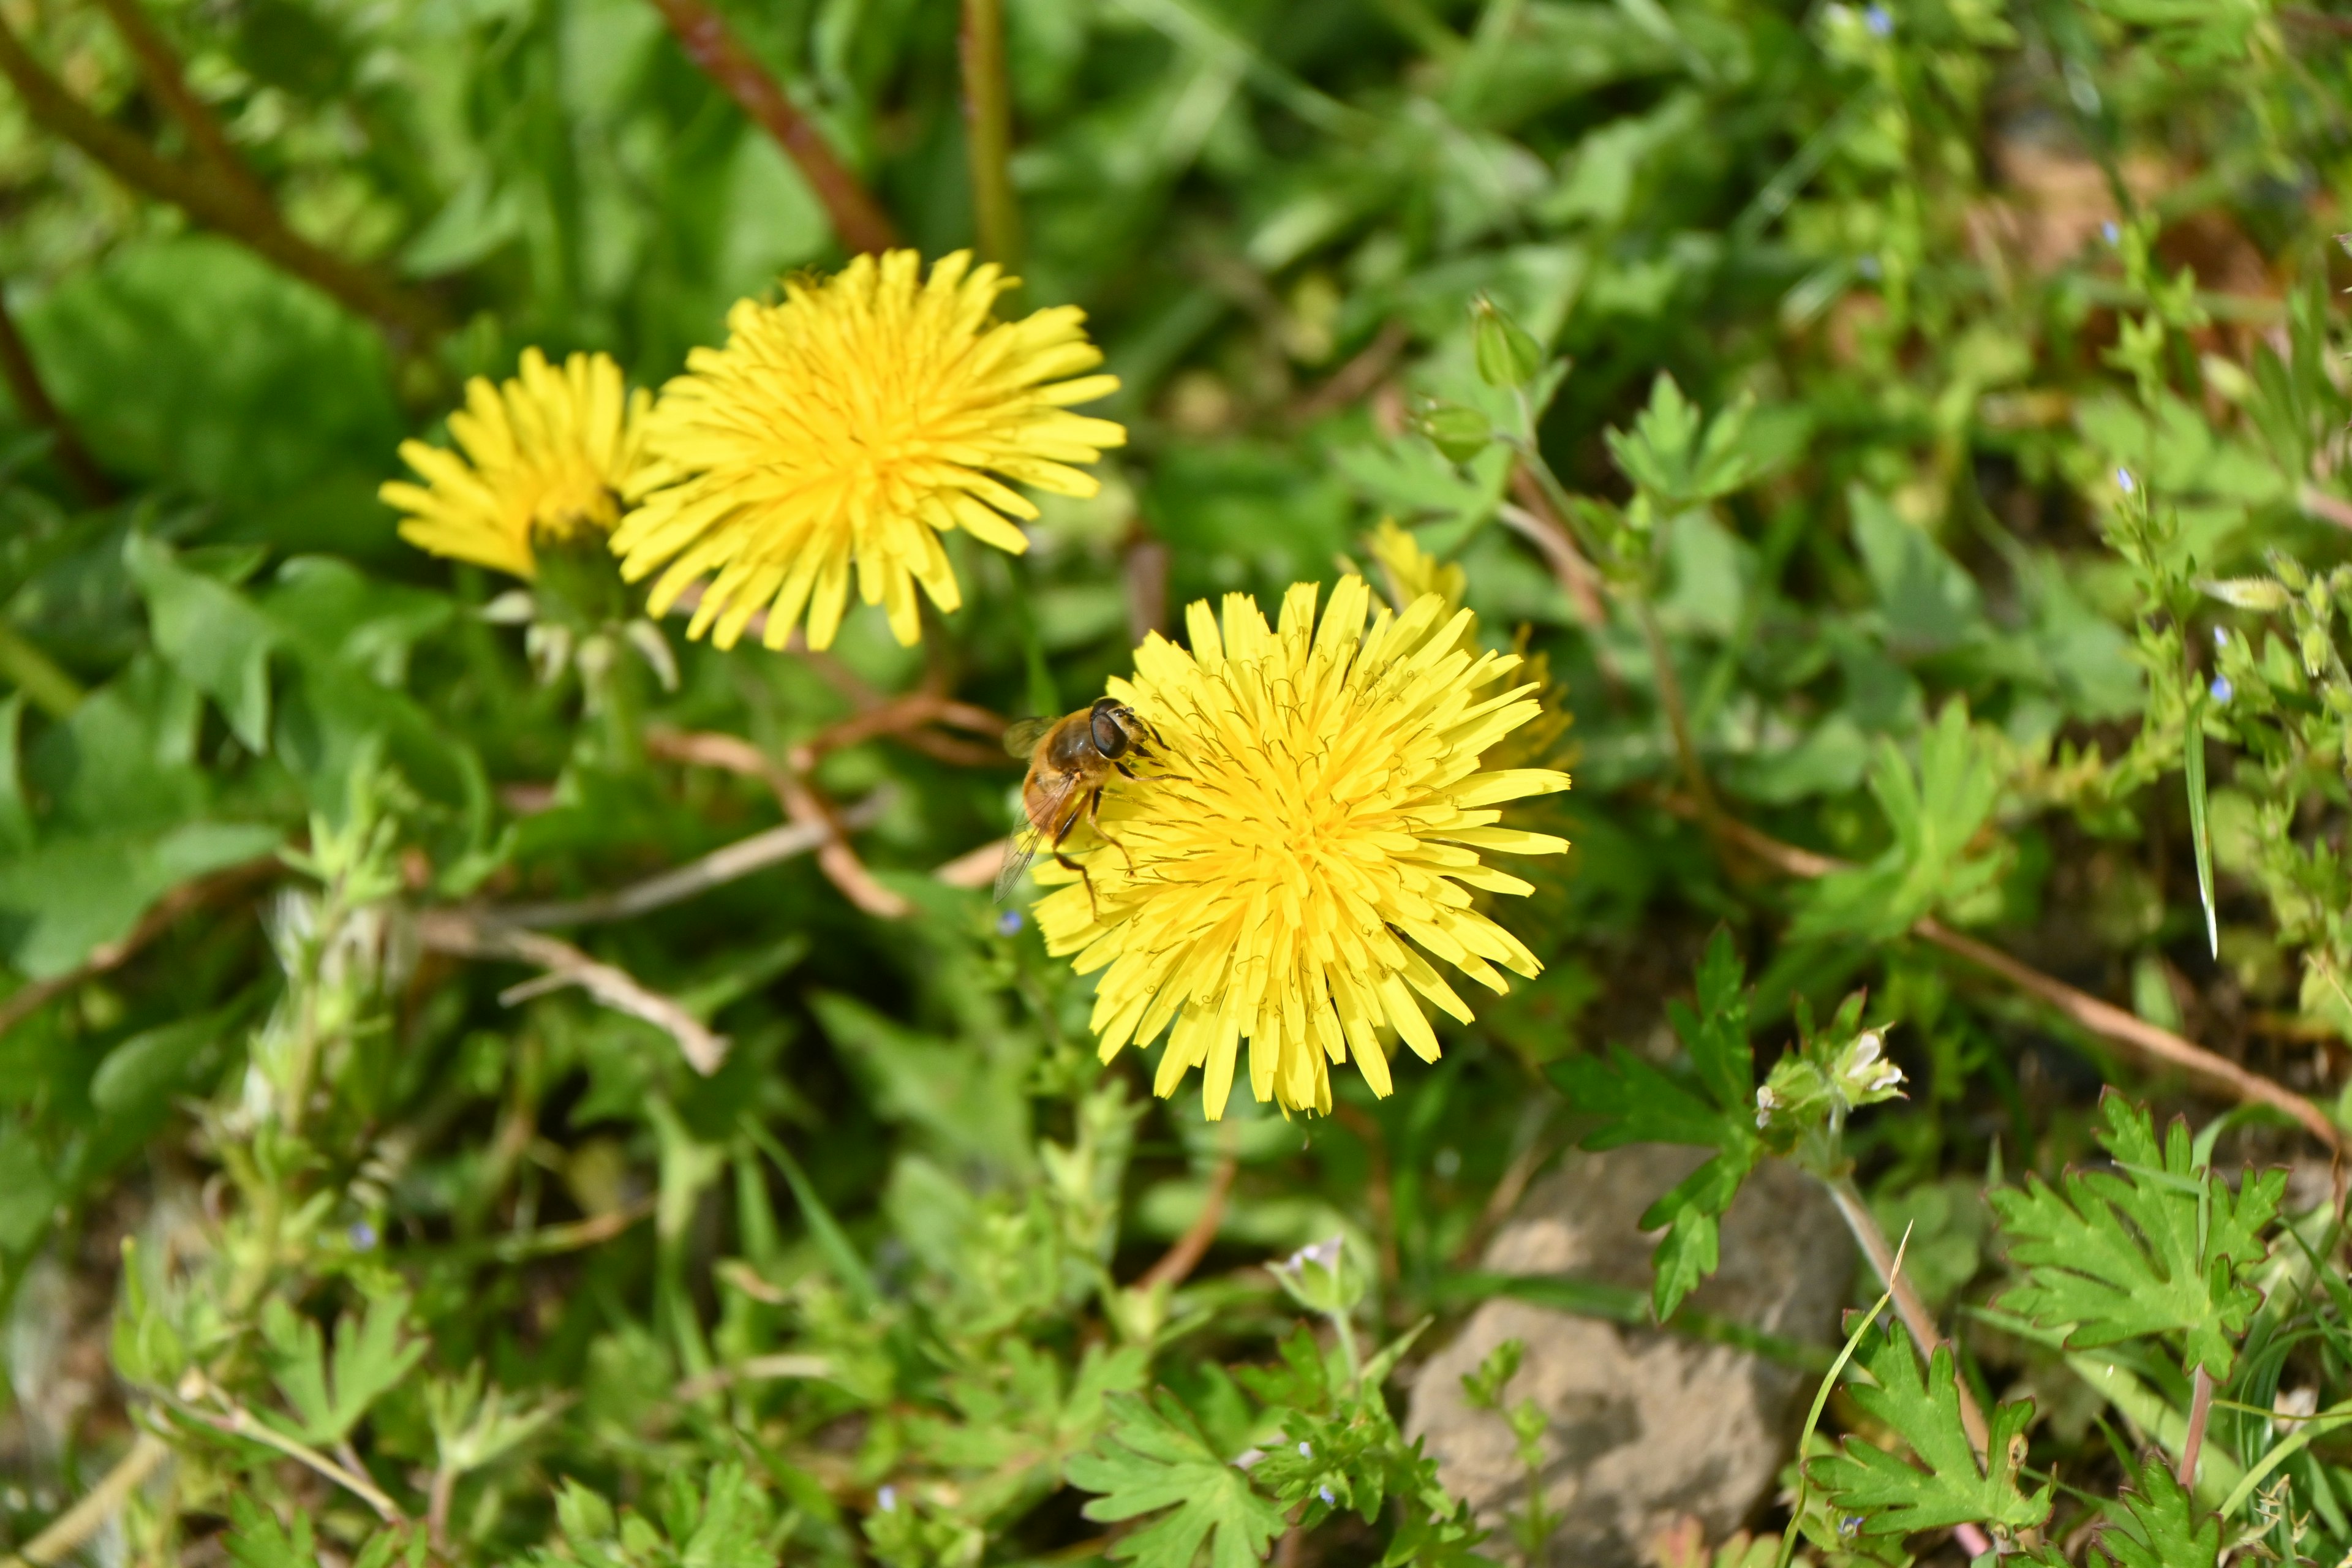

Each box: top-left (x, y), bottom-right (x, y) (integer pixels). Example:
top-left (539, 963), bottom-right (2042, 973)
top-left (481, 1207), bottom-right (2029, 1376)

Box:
top-left (1990, 1091), bottom-right (2286, 1378)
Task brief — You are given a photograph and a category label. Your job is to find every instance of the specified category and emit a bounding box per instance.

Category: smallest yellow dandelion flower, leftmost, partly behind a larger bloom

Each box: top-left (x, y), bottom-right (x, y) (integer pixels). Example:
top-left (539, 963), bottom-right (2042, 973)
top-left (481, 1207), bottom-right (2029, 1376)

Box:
top-left (376, 348), bottom-right (652, 578)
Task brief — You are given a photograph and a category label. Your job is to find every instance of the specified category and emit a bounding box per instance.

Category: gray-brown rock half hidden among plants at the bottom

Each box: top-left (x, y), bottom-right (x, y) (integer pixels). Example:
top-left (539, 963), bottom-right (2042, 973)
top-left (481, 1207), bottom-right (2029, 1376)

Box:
top-left (1406, 1145), bottom-right (1853, 1568)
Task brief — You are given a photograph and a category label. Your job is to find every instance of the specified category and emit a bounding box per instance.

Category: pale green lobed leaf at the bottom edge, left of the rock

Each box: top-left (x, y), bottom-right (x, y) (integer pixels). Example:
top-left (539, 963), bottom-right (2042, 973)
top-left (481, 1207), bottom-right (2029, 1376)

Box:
top-left (1068, 1394), bottom-right (1284, 1568)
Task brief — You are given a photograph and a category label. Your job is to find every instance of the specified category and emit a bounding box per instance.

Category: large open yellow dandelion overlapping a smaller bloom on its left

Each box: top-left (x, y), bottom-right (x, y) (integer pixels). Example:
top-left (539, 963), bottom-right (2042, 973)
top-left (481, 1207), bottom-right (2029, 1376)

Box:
top-left (611, 252), bottom-right (1126, 649)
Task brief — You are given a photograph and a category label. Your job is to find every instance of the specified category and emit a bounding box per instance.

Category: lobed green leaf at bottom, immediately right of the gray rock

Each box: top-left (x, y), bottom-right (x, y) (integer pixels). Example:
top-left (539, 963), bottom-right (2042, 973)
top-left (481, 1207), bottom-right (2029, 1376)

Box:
top-left (1809, 1330), bottom-right (2051, 1535)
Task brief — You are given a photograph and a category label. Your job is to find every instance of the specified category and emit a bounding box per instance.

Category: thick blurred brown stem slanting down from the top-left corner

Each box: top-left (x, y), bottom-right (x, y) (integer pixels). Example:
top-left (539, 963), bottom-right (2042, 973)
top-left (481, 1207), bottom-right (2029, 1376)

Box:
top-left (0, 21), bottom-right (442, 348)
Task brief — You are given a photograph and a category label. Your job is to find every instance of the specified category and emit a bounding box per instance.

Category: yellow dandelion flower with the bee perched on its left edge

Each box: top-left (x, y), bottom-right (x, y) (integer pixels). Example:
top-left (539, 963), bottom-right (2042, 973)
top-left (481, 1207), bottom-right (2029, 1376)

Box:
top-left (1037, 576), bottom-right (1569, 1117)
